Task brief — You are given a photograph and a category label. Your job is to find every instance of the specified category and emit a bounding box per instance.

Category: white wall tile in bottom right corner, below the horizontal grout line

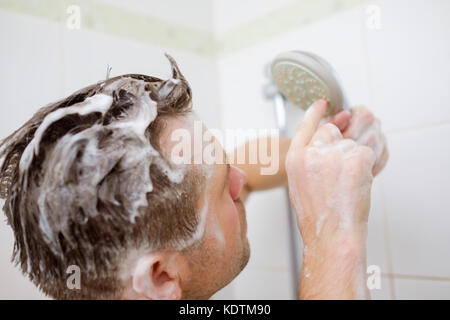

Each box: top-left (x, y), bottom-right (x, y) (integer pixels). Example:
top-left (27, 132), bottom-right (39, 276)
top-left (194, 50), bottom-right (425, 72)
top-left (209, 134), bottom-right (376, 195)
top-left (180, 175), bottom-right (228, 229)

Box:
top-left (395, 279), bottom-right (450, 300)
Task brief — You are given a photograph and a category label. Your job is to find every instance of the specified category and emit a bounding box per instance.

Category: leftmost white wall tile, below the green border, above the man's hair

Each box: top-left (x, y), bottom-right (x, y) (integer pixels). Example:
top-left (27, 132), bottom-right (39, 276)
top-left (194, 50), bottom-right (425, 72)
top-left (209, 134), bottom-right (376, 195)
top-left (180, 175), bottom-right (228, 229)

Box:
top-left (0, 11), bottom-right (63, 139)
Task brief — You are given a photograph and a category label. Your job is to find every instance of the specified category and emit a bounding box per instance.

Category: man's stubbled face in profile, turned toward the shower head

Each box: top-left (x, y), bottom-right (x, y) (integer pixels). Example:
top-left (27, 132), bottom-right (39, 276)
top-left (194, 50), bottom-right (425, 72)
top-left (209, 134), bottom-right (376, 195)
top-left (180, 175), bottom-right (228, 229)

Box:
top-left (160, 117), bottom-right (250, 299)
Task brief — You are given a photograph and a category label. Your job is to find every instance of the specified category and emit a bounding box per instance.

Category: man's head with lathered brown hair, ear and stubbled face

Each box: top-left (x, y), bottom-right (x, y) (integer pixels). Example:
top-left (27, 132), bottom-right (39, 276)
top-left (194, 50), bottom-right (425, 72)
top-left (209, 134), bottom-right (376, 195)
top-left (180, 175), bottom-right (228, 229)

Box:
top-left (0, 53), bottom-right (249, 299)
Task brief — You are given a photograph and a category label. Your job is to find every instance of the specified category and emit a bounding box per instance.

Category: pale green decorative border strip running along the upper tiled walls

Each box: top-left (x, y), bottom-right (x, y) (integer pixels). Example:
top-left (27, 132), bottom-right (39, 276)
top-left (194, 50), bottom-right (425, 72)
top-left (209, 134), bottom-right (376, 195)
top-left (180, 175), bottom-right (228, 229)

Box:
top-left (0, 0), bottom-right (365, 58)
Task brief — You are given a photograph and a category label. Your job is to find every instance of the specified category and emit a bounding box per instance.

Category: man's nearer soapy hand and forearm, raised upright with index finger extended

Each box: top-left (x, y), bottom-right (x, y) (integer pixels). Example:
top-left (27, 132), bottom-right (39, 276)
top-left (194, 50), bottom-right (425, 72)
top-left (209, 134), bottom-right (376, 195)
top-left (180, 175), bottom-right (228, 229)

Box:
top-left (286, 100), bottom-right (377, 299)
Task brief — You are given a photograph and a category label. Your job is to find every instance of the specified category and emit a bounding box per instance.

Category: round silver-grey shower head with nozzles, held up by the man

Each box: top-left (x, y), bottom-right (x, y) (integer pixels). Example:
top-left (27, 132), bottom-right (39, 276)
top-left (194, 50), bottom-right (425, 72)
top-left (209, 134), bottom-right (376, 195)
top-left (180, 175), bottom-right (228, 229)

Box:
top-left (271, 51), bottom-right (347, 115)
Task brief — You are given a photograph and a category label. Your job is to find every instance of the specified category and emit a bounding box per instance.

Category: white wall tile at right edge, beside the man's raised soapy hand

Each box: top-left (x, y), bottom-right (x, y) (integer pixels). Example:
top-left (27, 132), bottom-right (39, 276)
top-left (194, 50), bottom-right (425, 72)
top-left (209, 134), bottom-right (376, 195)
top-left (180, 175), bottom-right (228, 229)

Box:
top-left (381, 125), bottom-right (450, 277)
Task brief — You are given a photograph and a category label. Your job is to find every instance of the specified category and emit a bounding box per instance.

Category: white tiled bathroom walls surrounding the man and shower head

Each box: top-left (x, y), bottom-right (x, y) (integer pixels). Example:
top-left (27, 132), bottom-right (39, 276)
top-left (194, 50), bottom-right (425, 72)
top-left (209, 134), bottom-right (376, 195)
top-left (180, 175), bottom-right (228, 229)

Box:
top-left (0, 0), bottom-right (450, 299)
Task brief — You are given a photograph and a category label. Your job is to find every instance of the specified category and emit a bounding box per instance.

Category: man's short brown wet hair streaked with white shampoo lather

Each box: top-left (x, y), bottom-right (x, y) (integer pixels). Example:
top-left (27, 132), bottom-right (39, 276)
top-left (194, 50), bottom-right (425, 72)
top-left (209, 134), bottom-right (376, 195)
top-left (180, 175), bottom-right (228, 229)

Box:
top-left (0, 55), bottom-right (201, 299)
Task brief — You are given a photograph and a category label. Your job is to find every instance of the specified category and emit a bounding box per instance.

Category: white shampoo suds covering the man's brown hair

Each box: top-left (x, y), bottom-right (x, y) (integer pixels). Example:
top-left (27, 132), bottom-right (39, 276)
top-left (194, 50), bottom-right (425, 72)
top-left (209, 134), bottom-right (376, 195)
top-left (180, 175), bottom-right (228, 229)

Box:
top-left (29, 76), bottom-right (189, 254)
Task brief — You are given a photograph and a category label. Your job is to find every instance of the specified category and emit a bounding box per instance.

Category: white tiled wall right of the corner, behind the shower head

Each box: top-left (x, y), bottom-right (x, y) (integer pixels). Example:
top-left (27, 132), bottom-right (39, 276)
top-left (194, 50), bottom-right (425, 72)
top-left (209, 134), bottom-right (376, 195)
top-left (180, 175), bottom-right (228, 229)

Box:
top-left (214, 0), bottom-right (450, 299)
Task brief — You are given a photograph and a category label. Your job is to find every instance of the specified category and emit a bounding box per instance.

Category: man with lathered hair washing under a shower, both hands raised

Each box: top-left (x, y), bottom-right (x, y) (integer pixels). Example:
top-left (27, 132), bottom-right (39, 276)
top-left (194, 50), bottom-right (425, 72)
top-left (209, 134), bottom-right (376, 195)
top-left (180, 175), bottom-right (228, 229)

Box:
top-left (0, 56), bottom-right (387, 299)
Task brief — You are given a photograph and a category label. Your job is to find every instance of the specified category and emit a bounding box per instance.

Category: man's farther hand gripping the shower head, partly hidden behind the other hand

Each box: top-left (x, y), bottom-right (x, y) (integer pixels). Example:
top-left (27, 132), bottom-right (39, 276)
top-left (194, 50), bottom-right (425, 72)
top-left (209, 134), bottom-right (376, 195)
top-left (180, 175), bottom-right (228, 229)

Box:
top-left (331, 107), bottom-right (389, 176)
